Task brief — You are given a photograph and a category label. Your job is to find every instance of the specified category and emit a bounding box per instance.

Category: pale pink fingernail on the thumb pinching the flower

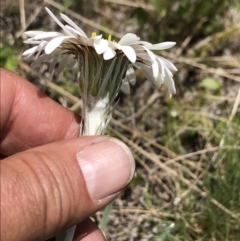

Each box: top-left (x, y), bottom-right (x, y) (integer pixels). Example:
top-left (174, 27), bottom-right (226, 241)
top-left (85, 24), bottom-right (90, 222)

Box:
top-left (77, 138), bottom-right (135, 200)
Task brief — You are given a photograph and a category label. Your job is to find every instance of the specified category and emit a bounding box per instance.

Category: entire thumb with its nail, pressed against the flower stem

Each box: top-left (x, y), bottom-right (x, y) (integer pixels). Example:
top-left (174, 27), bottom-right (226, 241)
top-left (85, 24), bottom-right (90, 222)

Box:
top-left (1, 137), bottom-right (135, 241)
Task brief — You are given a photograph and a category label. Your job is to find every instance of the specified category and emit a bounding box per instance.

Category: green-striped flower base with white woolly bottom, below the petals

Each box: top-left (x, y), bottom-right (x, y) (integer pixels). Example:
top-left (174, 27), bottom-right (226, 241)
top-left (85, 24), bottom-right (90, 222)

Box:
top-left (77, 48), bottom-right (129, 135)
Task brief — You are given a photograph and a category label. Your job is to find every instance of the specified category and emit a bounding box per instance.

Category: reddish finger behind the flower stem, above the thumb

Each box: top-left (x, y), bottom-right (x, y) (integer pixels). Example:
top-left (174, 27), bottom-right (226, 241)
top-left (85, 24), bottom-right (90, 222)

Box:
top-left (0, 68), bottom-right (81, 156)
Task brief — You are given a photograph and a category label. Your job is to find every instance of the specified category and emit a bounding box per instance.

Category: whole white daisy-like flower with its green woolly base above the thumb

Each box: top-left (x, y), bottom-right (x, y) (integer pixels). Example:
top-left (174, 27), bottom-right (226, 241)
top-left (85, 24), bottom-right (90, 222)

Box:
top-left (23, 8), bottom-right (177, 135)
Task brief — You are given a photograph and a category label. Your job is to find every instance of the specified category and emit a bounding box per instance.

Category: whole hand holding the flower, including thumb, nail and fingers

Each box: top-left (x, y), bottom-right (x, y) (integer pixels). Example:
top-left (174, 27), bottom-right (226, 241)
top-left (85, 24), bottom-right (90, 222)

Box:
top-left (0, 69), bottom-right (135, 241)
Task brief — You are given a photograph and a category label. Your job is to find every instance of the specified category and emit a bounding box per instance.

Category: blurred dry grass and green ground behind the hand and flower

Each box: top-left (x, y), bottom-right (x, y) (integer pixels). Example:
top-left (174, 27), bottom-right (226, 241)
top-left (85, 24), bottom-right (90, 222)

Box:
top-left (0, 0), bottom-right (240, 241)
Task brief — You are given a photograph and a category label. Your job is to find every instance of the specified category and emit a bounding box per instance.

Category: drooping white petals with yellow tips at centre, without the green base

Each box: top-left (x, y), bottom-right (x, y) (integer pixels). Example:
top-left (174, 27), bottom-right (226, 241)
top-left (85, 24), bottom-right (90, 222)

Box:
top-left (23, 8), bottom-right (177, 95)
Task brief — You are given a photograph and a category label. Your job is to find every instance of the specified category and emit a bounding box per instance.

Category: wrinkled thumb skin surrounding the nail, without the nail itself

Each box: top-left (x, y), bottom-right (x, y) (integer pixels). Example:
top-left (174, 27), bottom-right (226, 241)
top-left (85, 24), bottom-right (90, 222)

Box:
top-left (1, 137), bottom-right (113, 241)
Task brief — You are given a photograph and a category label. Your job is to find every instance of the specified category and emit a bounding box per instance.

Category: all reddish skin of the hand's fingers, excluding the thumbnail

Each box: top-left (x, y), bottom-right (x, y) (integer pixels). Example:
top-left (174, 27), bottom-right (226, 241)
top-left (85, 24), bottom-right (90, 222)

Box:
top-left (0, 68), bottom-right (123, 241)
